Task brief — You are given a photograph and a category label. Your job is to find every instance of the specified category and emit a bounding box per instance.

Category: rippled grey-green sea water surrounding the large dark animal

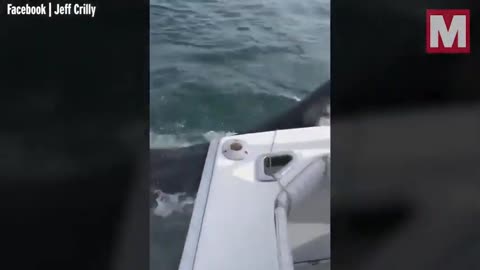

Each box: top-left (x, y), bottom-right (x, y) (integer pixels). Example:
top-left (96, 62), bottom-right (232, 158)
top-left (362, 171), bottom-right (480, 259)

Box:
top-left (150, 0), bottom-right (330, 270)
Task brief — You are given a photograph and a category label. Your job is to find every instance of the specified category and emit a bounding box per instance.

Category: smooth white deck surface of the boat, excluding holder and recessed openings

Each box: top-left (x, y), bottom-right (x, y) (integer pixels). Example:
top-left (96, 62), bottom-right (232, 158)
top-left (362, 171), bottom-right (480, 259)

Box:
top-left (180, 126), bottom-right (330, 270)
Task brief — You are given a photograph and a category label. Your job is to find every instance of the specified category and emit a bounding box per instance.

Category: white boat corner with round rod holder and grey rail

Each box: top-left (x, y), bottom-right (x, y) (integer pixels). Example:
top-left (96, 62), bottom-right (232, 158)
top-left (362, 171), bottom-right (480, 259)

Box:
top-left (179, 126), bottom-right (330, 270)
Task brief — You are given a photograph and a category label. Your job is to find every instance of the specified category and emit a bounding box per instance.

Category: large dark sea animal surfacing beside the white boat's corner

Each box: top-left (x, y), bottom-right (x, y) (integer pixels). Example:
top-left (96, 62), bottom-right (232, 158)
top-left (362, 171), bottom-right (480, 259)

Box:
top-left (150, 80), bottom-right (330, 202)
